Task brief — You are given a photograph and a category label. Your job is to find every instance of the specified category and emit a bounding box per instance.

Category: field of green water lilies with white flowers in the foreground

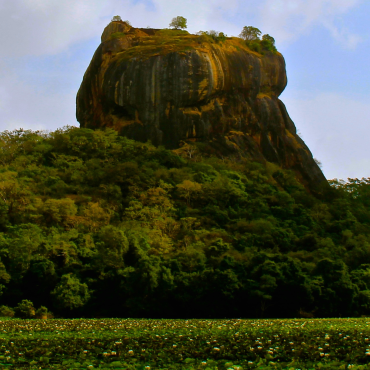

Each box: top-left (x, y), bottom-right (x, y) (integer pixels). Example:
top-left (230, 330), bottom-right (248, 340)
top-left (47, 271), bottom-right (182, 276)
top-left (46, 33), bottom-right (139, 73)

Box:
top-left (0, 318), bottom-right (370, 370)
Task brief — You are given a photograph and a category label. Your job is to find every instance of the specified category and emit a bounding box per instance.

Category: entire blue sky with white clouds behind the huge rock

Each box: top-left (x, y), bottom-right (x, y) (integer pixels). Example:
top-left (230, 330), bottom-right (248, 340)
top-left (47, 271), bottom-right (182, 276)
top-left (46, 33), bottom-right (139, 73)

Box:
top-left (0, 0), bottom-right (370, 180)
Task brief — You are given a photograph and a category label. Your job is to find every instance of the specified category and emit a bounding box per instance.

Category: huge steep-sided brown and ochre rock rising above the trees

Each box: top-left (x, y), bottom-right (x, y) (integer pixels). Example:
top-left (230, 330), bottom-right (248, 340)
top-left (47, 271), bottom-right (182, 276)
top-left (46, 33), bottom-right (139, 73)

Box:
top-left (77, 22), bottom-right (326, 189)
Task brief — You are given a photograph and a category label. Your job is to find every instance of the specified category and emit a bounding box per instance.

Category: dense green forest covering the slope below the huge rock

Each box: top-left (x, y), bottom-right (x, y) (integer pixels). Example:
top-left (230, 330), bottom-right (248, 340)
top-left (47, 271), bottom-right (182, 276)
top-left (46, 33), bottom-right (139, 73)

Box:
top-left (0, 126), bottom-right (370, 318)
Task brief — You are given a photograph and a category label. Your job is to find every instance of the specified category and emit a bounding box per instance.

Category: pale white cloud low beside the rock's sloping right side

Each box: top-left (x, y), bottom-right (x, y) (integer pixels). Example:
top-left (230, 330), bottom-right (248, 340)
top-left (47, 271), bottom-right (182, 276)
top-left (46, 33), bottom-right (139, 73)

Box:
top-left (282, 93), bottom-right (370, 179)
